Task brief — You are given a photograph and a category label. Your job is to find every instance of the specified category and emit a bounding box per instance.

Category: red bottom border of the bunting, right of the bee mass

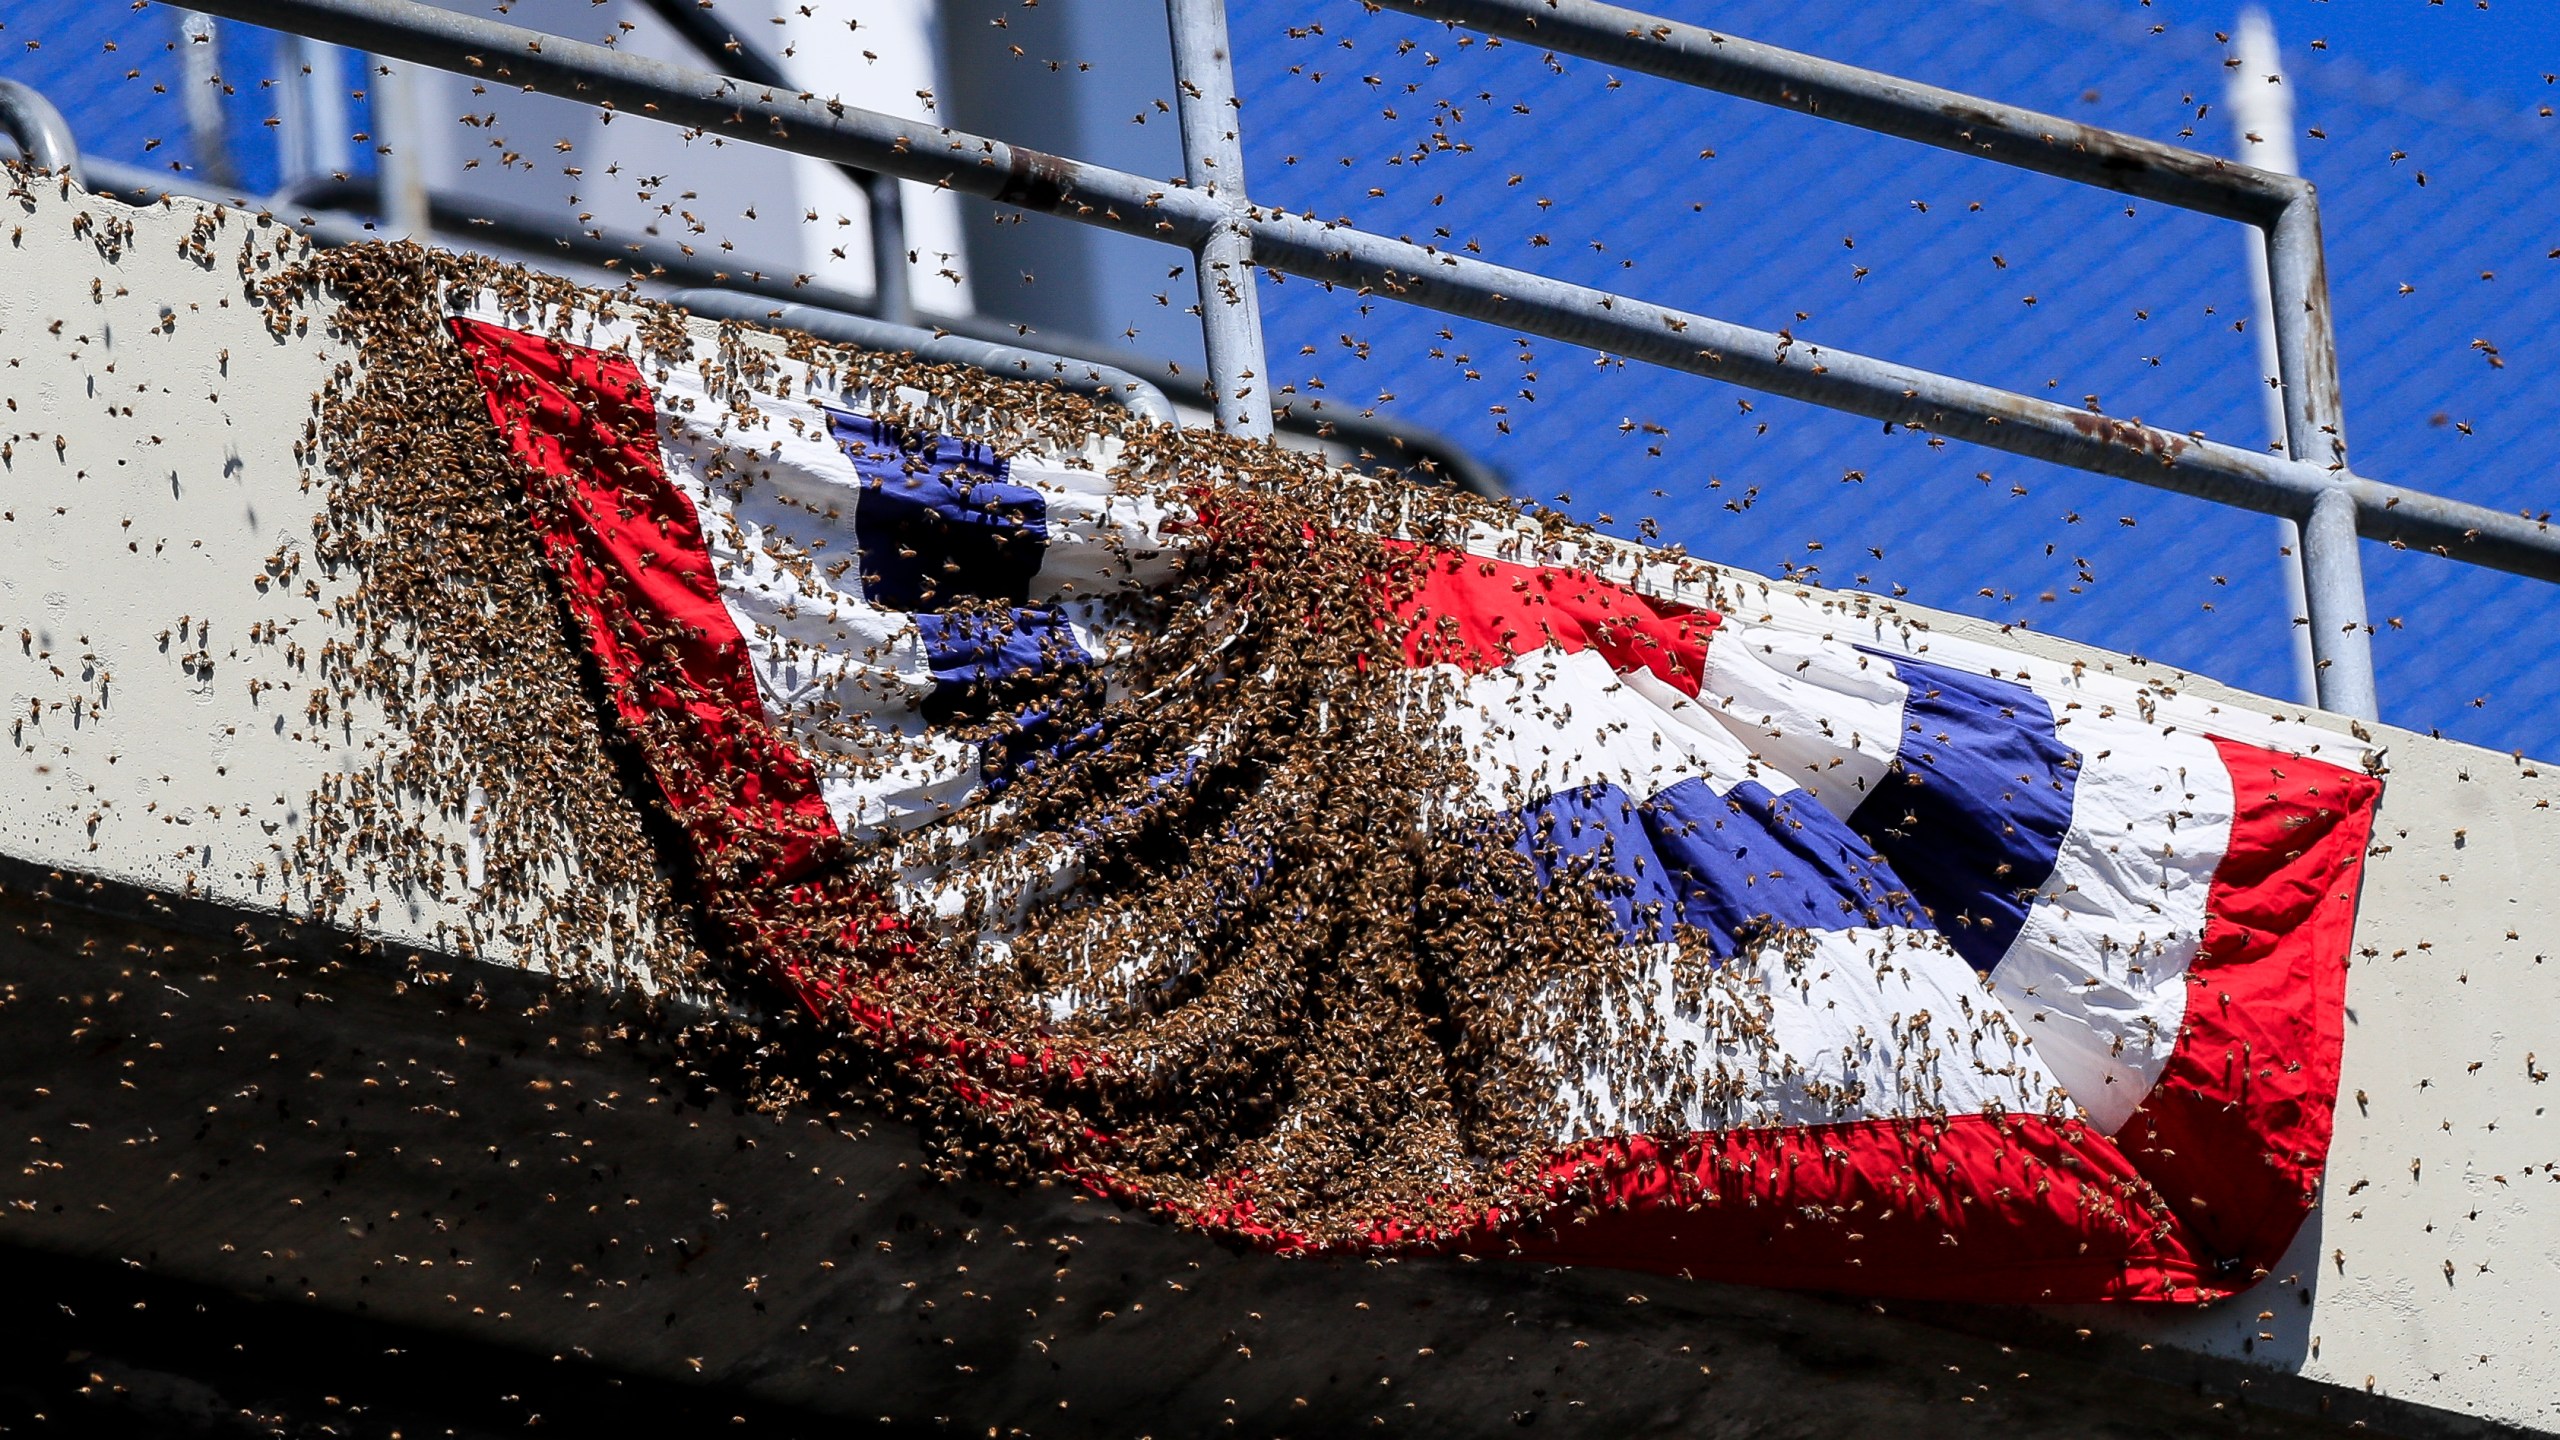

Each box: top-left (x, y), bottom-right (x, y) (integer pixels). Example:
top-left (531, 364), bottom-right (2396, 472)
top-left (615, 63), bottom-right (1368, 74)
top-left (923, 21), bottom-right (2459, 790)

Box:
top-left (1136, 1115), bottom-right (2227, 1304)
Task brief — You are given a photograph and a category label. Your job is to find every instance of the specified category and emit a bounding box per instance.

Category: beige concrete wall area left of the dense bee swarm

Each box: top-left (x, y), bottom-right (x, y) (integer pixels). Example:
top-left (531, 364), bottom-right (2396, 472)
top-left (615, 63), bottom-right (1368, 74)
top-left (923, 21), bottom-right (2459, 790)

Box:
top-left (0, 169), bottom-right (680, 958)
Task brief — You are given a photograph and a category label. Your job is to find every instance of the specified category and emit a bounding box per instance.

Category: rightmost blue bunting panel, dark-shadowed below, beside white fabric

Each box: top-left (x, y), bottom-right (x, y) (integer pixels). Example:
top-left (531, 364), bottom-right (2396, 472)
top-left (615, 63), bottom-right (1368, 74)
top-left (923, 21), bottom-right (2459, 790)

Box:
top-left (1848, 651), bottom-right (2079, 971)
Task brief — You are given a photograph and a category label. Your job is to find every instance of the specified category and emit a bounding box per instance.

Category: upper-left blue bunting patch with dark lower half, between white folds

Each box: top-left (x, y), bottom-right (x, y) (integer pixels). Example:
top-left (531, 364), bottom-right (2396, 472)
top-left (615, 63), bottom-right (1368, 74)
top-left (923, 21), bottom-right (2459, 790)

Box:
top-left (827, 410), bottom-right (1050, 610)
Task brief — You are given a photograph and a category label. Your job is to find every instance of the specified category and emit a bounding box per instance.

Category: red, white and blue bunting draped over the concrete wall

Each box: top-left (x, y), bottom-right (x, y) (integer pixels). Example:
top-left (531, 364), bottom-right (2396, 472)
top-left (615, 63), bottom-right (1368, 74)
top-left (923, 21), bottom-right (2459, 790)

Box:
top-left (453, 304), bottom-right (2381, 1302)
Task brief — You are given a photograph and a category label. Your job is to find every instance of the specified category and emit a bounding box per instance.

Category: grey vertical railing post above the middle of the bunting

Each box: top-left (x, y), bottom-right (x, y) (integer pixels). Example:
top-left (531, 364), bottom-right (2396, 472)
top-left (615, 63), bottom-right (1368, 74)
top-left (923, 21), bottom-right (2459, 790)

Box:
top-left (1165, 0), bottom-right (1272, 438)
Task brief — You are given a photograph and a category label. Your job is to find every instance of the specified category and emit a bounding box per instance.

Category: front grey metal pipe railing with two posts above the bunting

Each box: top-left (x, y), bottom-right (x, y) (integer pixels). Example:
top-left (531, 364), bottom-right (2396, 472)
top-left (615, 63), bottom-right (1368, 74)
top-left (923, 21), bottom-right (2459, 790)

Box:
top-left (104, 0), bottom-right (2560, 720)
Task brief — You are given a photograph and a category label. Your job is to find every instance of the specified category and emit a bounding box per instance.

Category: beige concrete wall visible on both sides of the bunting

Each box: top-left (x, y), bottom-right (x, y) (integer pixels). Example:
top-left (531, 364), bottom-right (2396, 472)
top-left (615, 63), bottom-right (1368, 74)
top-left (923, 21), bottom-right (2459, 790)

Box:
top-left (0, 174), bottom-right (2560, 1432)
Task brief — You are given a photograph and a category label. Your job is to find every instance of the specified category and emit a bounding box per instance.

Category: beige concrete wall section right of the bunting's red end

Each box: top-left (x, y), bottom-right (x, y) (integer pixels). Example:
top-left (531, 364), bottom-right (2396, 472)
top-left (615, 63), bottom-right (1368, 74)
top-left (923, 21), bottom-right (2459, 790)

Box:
top-left (2099, 728), bottom-right (2560, 1432)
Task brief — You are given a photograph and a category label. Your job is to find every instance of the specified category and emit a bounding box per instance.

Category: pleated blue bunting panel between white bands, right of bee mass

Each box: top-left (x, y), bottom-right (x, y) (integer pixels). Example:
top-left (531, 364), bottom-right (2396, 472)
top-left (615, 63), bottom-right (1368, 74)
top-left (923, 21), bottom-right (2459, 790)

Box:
top-left (1521, 779), bottom-right (1928, 956)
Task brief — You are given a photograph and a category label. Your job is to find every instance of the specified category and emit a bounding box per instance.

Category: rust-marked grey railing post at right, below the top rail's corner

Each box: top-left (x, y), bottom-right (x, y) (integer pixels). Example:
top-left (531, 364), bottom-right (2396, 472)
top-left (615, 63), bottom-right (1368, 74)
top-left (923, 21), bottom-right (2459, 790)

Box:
top-left (2266, 184), bottom-right (2381, 720)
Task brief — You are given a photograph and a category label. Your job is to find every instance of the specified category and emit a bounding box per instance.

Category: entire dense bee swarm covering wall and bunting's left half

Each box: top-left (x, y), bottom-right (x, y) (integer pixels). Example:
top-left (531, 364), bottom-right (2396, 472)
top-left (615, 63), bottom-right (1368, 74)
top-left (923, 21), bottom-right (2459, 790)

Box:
top-left (264, 246), bottom-right (2140, 1245)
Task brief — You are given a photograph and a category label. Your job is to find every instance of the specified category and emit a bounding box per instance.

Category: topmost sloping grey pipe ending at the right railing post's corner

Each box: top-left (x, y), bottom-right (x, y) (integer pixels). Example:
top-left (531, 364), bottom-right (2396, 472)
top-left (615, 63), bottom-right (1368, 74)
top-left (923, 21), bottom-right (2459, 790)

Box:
top-left (1377, 0), bottom-right (2301, 223)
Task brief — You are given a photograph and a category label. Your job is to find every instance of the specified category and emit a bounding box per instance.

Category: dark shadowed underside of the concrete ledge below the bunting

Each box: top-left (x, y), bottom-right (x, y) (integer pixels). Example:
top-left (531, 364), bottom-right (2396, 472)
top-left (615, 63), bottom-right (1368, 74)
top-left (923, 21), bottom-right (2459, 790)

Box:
top-left (0, 881), bottom-right (2396, 1440)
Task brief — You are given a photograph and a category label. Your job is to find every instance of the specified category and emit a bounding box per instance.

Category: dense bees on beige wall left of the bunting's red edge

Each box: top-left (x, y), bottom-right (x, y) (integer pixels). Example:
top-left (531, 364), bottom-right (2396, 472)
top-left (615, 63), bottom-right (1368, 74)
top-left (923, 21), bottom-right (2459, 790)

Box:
top-left (256, 233), bottom-right (707, 992)
